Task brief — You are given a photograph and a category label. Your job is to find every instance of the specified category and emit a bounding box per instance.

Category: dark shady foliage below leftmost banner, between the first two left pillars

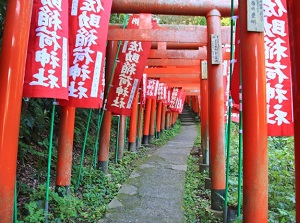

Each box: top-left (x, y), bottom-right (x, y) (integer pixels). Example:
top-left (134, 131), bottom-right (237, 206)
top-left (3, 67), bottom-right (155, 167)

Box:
top-left (18, 99), bottom-right (59, 184)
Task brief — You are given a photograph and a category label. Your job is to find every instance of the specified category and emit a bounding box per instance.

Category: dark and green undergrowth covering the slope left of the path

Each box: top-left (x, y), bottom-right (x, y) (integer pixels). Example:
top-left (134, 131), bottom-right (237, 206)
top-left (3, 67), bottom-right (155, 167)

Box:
top-left (18, 99), bottom-right (141, 222)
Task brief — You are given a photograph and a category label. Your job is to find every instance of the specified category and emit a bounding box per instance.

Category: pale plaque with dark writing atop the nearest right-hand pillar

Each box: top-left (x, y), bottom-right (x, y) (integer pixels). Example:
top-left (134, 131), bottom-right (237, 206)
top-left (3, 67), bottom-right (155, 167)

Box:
top-left (247, 0), bottom-right (264, 32)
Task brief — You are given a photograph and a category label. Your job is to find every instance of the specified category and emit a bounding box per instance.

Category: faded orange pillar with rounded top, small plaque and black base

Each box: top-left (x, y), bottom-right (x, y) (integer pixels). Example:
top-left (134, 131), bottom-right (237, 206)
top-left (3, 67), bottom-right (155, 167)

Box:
top-left (206, 9), bottom-right (225, 211)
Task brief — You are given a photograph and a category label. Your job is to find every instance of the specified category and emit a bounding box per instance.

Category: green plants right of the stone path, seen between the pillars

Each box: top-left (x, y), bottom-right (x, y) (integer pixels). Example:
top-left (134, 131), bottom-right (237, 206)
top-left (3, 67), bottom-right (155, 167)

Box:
top-left (184, 124), bottom-right (296, 223)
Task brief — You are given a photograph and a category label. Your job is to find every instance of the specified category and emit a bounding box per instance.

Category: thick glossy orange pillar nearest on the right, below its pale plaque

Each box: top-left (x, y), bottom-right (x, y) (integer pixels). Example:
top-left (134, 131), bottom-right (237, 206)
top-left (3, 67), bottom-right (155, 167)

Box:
top-left (239, 1), bottom-right (268, 223)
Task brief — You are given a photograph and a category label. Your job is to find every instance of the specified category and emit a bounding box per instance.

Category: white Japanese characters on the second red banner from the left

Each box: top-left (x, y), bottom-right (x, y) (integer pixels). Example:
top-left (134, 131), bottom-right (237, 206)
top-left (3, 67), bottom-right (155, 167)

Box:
top-left (69, 0), bottom-right (104, 99)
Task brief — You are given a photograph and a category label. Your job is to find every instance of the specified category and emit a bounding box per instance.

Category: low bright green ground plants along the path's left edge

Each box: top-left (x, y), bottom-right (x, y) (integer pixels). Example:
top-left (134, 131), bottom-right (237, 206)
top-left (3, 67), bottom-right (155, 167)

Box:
top-left (18, 121), bottom-right (181, 223)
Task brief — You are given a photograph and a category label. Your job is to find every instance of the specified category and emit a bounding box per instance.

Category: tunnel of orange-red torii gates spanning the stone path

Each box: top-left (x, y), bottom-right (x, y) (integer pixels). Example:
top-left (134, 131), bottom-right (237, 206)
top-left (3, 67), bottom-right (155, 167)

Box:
top-left (0, 0), bottom-right (300, 223)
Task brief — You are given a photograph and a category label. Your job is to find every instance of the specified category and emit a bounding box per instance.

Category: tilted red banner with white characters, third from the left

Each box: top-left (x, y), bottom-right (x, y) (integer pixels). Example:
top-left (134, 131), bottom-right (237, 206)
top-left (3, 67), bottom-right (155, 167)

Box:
top-left (106, 15), bottom-right (151, 116)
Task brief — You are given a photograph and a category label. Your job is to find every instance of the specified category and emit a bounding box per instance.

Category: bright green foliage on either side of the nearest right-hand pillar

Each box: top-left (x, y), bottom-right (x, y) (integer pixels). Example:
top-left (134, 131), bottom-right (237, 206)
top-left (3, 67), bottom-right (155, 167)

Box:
top-left (228, 123), bottom-right (295, 223)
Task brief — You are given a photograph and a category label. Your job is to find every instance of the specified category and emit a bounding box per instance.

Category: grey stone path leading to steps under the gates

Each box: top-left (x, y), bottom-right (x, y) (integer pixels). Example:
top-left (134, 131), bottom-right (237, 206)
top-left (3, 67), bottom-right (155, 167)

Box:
top-left (99, 111), bottom-right (197, 223)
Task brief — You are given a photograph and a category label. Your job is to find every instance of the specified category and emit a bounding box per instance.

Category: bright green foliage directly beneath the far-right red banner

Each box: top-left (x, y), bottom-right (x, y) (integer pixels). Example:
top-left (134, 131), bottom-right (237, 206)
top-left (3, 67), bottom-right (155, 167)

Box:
top-left (269, 137), bottom-right (296, 223)
